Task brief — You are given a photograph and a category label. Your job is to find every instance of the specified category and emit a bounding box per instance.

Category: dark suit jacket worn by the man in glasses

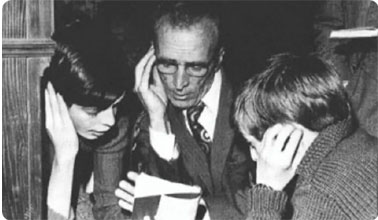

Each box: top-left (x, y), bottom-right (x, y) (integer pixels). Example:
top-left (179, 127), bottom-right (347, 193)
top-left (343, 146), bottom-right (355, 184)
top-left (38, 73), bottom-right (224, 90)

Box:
top-left (132, 76), bottom-right (251, 219)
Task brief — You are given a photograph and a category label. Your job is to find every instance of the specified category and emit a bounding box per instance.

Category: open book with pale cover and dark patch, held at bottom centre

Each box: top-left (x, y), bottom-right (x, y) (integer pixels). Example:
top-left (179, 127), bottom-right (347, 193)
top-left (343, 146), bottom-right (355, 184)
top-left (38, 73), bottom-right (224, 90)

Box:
top-left (133, 173), bottom-right (201, 220)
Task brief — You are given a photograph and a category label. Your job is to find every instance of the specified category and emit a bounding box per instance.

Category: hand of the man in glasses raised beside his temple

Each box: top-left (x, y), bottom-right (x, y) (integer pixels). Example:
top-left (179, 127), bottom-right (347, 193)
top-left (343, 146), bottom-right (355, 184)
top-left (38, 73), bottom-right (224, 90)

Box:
top-left (134, 47), bottom-right (169, 133)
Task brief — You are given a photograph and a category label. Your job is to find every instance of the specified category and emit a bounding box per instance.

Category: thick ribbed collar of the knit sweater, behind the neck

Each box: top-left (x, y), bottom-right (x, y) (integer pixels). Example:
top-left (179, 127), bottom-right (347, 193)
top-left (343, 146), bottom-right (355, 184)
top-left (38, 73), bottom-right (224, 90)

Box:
top-left (296, 117), bottom-right (353, 177)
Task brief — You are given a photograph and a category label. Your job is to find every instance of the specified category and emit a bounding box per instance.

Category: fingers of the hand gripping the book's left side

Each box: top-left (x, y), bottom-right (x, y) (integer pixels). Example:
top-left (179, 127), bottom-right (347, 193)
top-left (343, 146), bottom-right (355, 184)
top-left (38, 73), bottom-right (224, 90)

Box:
top-left (115, 172), bottom-right (139, 212)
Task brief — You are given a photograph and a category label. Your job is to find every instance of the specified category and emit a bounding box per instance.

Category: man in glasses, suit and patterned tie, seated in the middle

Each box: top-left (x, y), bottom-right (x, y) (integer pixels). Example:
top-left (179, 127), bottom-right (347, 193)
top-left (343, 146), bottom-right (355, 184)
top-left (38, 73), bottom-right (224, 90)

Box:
top-left (116, 2), bottom-right (250, 219)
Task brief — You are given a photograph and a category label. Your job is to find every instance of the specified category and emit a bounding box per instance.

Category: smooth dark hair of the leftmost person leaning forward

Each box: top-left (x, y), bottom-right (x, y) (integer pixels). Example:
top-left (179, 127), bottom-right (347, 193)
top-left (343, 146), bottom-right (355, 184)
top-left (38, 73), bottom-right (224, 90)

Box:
top-left (44, 21), bottom-right (132, 110)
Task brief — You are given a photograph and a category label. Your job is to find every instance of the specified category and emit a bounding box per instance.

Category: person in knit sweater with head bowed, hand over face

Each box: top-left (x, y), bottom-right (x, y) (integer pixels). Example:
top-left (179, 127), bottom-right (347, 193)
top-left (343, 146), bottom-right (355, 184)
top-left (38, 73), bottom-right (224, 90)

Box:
top-left (235, 54), bottom-right (378, 220)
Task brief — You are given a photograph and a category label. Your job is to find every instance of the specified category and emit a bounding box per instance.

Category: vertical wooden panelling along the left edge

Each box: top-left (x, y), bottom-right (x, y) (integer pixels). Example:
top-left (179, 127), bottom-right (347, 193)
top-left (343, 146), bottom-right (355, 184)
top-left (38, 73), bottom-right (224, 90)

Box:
top-left (2, 0), bottom-right (54, 219)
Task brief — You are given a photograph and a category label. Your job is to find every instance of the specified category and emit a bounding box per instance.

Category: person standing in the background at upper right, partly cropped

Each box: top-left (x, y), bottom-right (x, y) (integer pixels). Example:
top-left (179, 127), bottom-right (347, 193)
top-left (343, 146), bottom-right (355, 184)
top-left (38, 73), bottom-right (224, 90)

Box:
top-left (314, 0), bottom-right (378, 138)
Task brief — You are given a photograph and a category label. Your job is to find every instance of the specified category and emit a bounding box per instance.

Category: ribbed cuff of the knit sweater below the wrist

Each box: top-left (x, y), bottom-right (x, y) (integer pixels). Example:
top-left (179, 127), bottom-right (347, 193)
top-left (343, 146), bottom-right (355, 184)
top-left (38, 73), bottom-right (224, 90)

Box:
top-left (250, 185), bottom-right (288, 217)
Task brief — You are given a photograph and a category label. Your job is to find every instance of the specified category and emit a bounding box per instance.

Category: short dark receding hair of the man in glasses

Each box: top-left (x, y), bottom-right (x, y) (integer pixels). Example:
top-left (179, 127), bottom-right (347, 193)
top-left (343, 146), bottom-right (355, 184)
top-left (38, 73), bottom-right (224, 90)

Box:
top-left (153, 1), bottom-right (222, 49)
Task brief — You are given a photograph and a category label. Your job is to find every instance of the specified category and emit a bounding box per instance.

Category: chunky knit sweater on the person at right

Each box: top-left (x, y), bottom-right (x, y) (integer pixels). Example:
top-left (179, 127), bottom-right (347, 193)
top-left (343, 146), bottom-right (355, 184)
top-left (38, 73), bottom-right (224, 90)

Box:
top-left (239, 120), bottom-right (378, 220)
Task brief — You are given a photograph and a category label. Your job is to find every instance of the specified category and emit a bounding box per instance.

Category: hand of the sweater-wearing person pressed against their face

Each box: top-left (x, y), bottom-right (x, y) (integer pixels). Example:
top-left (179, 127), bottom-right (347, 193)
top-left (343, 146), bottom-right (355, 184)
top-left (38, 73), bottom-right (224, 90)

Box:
top-left (251, 124), bottom-right (306, 190)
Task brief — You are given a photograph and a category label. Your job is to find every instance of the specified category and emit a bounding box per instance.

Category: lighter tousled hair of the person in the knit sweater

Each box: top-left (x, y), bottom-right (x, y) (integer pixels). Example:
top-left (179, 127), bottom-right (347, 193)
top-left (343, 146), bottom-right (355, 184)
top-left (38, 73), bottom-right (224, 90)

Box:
top-left (234, 53), bottom-right (350, 140)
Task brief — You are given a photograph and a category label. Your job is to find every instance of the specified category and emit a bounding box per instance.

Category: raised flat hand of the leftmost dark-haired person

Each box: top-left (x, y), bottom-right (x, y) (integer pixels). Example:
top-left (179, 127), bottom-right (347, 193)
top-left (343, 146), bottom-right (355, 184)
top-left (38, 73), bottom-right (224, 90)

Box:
top-left (45, 82), bottom-right (79, 165)
